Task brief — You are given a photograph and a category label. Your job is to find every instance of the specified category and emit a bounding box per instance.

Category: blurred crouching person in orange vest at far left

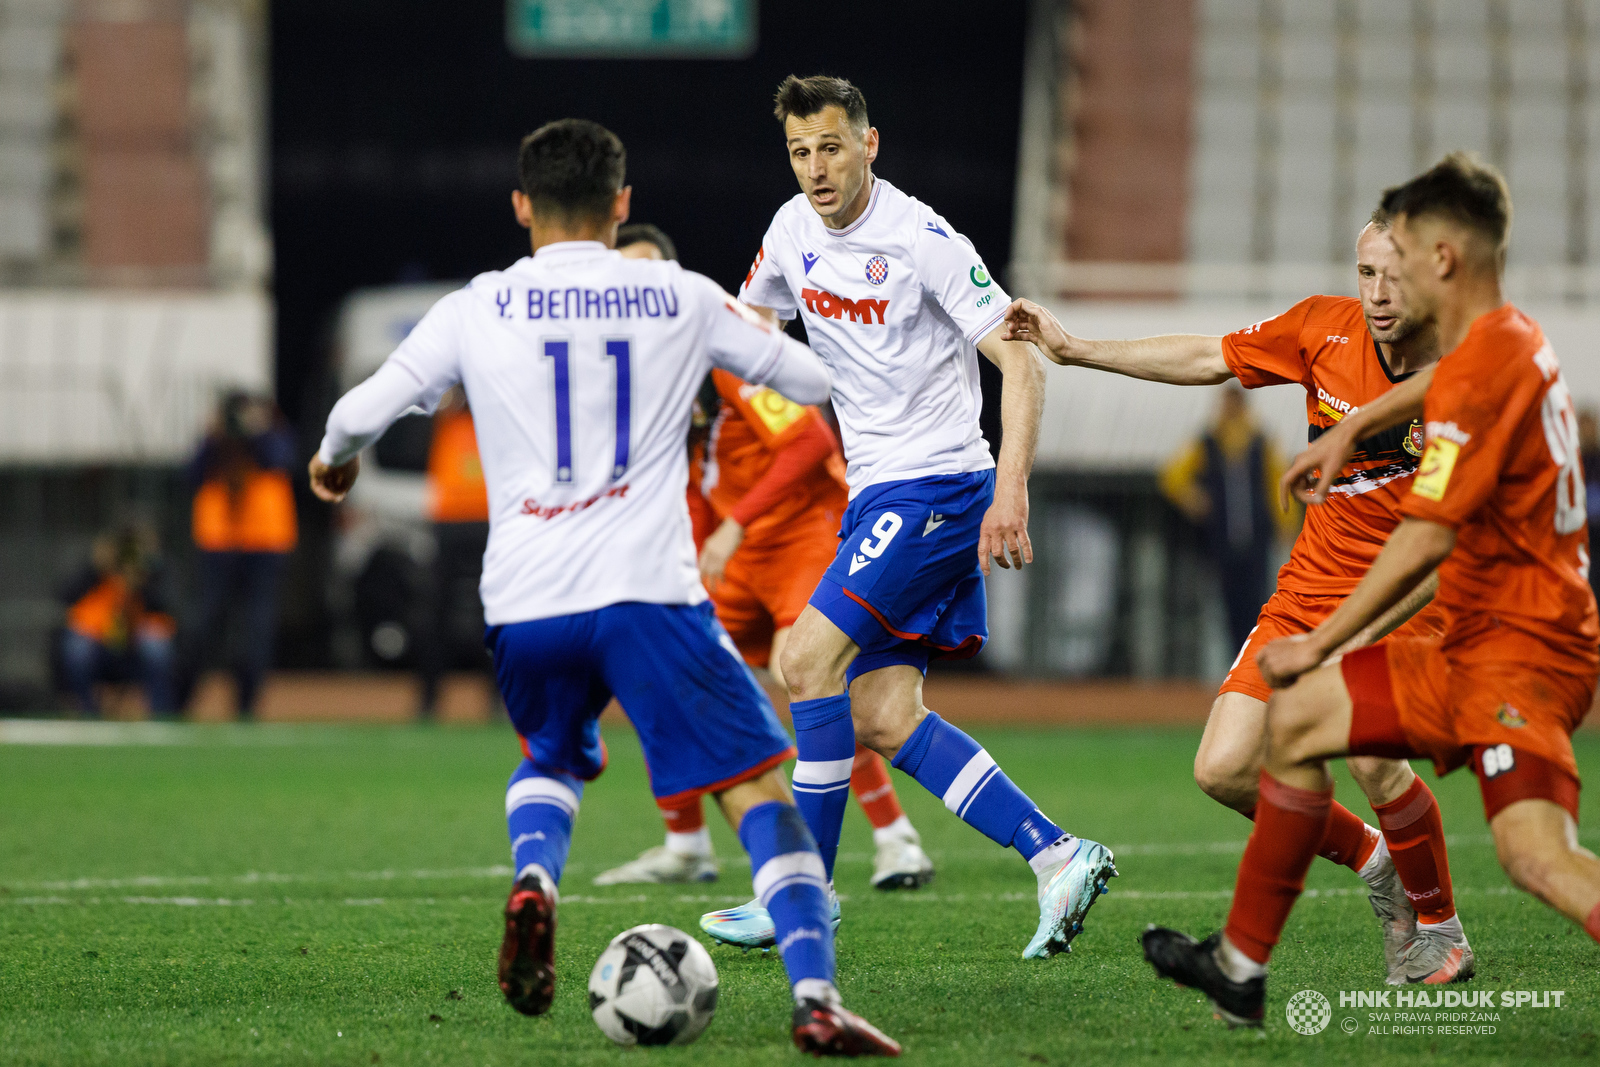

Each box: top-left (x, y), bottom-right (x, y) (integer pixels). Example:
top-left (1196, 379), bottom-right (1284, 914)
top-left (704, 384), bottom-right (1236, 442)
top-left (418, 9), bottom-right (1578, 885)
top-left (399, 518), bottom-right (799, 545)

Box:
top-left (61, 523), bottom-right (178, 718)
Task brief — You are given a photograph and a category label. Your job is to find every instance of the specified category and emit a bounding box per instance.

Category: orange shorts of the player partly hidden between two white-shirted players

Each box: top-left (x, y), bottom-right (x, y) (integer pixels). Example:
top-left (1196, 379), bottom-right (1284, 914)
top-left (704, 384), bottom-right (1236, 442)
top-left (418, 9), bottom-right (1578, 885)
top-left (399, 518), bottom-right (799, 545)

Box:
top-left (710, 514), bottom-right (838, 667)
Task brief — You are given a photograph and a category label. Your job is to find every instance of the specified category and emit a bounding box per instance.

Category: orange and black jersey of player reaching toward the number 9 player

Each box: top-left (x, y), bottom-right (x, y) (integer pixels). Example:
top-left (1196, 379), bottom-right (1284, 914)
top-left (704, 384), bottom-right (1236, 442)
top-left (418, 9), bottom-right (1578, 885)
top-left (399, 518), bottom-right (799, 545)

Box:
top-left (1222, 296), bottom-right (1422, 597)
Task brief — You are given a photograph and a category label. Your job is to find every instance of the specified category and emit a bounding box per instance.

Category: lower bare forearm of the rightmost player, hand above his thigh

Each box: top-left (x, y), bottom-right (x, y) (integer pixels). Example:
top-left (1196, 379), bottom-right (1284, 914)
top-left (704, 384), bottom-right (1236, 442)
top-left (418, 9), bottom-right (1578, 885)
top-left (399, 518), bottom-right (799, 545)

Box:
top-left (1256, 518), bottom-right (1456, 689)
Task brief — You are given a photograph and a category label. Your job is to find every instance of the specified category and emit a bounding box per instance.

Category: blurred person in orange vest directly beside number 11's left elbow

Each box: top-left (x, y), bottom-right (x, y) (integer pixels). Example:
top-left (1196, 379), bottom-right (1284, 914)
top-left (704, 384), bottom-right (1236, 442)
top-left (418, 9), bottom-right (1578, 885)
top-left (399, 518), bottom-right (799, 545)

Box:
top-left (418, 386), bottom-right (491, 718)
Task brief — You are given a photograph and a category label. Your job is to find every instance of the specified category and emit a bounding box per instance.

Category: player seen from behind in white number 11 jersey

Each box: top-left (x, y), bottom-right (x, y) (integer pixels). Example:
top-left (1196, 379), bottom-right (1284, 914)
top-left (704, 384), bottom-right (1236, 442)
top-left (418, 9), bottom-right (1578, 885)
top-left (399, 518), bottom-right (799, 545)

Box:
top-left (310, 118), bottom-right (899, 1056)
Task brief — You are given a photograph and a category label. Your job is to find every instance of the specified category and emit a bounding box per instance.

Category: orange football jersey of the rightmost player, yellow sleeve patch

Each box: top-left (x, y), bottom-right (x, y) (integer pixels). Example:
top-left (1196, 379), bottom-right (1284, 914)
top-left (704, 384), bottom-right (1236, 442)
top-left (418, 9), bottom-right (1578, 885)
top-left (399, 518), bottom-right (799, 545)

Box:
top-left (1400, 304), bottom-right (1600, 672)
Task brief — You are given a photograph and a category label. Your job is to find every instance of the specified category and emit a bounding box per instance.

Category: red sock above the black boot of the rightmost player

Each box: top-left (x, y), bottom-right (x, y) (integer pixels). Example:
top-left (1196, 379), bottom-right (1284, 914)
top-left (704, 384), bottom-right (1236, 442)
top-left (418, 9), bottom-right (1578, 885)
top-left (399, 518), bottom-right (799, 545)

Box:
top-left (1224, 771), bottom-right (1333, 963)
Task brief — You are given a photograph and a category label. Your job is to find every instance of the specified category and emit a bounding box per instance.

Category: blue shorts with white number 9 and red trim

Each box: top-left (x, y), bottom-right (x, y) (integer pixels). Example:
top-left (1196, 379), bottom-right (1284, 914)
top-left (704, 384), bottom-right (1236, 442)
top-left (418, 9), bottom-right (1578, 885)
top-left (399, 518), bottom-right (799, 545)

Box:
top-left (811, 469), bottom-right (995, 680)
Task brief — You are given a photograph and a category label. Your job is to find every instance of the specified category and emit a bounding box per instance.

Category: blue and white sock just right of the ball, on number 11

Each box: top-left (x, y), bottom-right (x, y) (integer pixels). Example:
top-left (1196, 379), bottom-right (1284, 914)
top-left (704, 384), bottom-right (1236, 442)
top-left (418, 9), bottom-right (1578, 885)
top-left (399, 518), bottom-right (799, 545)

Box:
top-left (739, 800), bottom-right (834, 992)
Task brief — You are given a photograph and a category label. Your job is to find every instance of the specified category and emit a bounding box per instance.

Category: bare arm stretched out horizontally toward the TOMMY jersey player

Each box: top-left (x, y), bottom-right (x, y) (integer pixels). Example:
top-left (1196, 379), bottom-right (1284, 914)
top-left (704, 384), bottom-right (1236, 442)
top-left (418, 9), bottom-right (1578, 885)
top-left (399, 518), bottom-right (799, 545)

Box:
top-left (1000, 299), bottom-right (1234, 386)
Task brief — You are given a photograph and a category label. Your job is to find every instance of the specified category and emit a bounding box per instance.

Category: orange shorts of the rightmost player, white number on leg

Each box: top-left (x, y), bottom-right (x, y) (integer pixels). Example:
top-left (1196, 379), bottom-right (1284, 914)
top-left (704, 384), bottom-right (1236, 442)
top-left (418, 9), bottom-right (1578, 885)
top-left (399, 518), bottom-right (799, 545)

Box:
top-left (1341, 638), bottom-right (1595, 819)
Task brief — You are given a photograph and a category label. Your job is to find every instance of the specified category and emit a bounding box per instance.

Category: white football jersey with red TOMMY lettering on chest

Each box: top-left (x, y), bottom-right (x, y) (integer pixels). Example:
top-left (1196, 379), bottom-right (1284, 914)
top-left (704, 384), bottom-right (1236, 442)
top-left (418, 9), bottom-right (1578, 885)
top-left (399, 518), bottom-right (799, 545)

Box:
top-left (739, 178), bottom-right (1011, 496)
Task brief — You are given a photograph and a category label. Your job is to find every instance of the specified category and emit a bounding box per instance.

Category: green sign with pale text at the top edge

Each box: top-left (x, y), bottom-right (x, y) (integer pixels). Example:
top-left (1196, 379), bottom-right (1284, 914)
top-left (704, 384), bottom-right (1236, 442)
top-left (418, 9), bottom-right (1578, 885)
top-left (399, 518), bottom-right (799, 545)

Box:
top-left (506, 0), bottom-right (757, 59)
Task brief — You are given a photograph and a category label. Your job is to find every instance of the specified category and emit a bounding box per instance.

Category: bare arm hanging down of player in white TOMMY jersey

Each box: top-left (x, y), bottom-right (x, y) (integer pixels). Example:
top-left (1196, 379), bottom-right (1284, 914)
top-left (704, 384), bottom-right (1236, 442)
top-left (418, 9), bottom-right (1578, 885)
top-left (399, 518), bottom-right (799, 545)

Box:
top-left (978, 325), bottom-right (1045, 574)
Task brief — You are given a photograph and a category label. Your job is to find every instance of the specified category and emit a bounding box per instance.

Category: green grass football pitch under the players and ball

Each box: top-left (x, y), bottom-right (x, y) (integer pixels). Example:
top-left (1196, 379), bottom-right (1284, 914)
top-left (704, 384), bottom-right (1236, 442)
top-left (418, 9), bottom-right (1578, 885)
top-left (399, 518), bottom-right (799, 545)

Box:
top-left (0, 726), bottom-right (1600, 1067)
